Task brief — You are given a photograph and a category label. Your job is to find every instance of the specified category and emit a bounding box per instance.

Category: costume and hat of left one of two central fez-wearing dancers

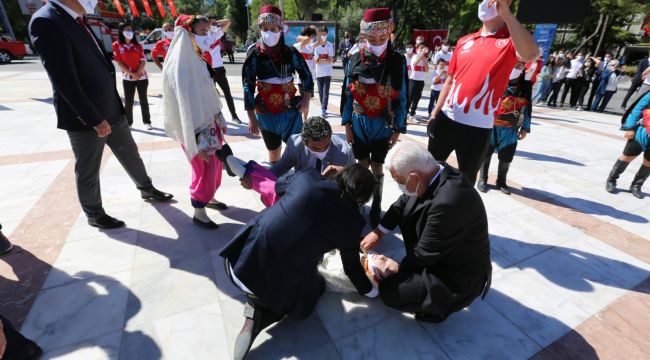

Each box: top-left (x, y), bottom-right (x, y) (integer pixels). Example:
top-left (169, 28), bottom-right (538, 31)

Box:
top-left (242, 5), bottom-right (314, 156)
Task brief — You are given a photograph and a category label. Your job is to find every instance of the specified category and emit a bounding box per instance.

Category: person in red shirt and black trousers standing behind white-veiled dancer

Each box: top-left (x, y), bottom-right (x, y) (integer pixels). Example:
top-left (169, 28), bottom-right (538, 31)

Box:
top-left (113, 23), bottom-right (153, 130)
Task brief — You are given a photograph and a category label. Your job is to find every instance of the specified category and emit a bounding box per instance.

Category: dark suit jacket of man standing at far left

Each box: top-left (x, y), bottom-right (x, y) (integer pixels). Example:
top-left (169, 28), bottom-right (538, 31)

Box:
top-left (29, 2), bottom-right (125, 131)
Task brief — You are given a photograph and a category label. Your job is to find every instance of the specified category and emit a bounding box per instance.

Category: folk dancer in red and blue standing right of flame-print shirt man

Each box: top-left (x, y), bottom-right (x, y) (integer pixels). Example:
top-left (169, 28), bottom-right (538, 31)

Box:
top-left (476, 64), bottom-right (532, 195)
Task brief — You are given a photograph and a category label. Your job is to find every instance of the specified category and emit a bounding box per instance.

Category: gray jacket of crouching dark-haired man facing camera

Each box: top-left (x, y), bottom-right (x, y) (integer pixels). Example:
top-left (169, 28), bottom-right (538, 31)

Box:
top-left (269, 134), bottom-right (356, 176)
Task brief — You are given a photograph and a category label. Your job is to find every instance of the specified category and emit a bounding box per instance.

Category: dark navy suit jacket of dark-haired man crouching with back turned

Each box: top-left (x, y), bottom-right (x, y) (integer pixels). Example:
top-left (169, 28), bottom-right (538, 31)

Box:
top-left (220, 168), bottom-right (372, 318)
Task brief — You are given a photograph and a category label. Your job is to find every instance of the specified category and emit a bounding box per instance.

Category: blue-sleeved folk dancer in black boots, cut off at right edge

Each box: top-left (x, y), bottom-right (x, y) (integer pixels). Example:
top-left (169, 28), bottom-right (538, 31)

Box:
top-left (606, 91), bottom-right (650, 199)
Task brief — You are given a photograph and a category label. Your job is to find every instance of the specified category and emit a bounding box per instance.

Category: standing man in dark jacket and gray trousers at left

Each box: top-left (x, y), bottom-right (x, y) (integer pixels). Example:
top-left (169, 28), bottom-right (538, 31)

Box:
top-left (29, 0), bottom-right (172, 228)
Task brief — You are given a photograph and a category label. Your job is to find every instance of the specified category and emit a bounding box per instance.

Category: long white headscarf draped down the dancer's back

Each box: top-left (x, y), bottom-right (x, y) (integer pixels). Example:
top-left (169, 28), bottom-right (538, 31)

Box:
top-left (161, 26), bottom-right (226, 160)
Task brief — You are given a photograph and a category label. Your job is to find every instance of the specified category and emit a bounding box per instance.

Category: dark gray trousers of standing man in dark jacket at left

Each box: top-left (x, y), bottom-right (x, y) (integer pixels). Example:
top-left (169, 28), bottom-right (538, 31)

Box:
top-left (68, 120), bottom-right (152, 218)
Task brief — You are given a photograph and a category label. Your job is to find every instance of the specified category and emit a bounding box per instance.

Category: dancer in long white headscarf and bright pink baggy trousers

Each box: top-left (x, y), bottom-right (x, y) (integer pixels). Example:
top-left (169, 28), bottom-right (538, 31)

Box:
top-left (162, 15), bottom-right (226, 229)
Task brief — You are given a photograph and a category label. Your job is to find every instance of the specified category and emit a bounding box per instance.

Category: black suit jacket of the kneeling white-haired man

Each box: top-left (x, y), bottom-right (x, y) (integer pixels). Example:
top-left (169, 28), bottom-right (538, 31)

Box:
top-left (381, 163), bottom-right (492, 313)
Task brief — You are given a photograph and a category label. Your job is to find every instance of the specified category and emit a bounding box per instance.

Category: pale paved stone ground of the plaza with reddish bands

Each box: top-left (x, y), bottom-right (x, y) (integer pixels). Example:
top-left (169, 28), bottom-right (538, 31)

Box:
top-left (0, 59), bottom-right (650, 360)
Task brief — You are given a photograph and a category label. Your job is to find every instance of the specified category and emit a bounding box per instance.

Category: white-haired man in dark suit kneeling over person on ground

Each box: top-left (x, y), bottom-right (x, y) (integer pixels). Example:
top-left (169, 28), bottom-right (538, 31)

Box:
top-left (361, 141), bottom-right (492, 322)
